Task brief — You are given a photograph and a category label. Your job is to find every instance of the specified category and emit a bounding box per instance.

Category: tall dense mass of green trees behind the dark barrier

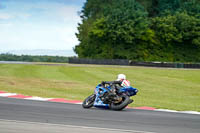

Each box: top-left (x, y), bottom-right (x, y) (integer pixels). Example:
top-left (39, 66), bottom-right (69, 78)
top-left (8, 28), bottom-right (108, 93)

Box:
top-left (74, 0), bottom-right (200, 62)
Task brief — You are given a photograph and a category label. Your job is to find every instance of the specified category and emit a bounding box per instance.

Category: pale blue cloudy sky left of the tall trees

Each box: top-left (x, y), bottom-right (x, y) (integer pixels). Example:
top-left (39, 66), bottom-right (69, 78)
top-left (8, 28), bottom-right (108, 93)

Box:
top-left (0, 0), bottom-right (85, 51)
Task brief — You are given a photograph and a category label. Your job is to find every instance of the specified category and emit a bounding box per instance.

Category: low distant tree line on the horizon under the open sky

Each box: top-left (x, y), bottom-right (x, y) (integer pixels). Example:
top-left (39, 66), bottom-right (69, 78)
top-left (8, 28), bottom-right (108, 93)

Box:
top-left (0, 53), bottom-right (69, 63)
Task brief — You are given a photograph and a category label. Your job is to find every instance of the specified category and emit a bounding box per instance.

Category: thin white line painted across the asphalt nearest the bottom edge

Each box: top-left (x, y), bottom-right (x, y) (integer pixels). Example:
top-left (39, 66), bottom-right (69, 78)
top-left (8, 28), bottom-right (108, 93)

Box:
top-left (0, 119), bottom-right (155, 133)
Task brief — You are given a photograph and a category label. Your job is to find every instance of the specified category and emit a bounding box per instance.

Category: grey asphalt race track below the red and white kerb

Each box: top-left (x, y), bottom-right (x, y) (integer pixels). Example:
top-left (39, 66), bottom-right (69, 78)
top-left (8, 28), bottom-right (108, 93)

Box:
top-left (0, 97), bottom-right (200, 133)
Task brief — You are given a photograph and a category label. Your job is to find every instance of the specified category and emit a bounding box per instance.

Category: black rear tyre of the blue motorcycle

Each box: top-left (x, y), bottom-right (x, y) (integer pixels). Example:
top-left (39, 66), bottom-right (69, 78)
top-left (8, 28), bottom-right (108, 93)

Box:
top-left (110, 95), bottom-right (130, 111)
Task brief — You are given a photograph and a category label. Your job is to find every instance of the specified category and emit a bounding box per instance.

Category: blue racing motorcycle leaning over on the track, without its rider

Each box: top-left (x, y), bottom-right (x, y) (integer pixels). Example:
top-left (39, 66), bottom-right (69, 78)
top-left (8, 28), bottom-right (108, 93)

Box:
top-left (82, 82), bottom-right (138, 110)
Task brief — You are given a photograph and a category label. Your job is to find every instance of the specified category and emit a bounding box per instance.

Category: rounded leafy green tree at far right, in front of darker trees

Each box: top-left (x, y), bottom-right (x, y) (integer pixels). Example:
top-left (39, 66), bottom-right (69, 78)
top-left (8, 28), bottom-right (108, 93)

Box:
top-left (152, 12), bottom-right (200, 61)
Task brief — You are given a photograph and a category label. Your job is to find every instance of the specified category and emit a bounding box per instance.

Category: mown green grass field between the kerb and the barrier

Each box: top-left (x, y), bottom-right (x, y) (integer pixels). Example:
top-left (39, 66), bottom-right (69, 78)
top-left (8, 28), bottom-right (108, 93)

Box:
top-left (0, 64), bottom-right (200, 111)
